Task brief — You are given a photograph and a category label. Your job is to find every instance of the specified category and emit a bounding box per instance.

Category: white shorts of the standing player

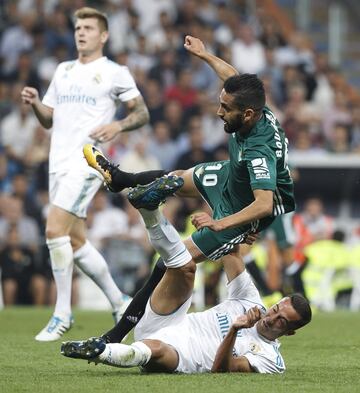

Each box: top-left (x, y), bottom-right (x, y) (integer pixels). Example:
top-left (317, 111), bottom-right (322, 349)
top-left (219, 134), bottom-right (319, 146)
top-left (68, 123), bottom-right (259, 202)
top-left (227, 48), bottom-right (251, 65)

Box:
top-left (49, 168), bottom-right (103, 218)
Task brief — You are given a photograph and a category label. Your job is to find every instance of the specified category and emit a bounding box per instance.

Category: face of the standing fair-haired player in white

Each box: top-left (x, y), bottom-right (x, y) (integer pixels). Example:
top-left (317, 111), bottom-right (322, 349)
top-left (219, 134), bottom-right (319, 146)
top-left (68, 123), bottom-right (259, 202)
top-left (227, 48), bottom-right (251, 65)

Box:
top-left (75, 18), bottom-right (108, 55)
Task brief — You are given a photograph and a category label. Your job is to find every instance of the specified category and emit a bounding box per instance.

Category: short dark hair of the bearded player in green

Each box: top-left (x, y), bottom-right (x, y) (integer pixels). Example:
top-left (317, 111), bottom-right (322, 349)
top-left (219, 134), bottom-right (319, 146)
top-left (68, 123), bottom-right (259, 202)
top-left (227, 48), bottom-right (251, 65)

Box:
top-left (224, 74), bottom-right (265, 111)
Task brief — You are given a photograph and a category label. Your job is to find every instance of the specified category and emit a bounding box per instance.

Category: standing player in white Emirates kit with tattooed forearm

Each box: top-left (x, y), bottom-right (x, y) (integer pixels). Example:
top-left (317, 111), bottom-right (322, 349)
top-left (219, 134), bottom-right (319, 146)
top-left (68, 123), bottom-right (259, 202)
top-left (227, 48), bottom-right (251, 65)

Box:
top-left (21, 7), bottom-right (149, 341)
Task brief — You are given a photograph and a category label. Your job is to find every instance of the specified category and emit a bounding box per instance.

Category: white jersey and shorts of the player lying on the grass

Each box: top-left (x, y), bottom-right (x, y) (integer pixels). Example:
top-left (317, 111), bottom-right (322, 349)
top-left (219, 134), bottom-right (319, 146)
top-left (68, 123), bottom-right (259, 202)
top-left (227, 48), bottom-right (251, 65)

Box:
top-left (139, 271), bottom-right (285, 373)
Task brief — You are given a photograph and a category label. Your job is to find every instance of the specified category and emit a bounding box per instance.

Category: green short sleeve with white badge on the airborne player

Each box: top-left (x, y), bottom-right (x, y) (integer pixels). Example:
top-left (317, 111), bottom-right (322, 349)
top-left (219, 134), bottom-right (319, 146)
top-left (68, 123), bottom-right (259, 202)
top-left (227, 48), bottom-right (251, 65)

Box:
top-left (245, 146), bottom-right (277, 191)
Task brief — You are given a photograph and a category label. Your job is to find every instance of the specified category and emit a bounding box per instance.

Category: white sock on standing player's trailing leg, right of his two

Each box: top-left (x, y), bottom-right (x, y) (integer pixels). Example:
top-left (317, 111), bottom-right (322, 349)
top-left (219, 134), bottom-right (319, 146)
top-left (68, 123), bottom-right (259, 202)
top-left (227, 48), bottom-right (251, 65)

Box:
top-left (74, 240), bottom-right (122, 311)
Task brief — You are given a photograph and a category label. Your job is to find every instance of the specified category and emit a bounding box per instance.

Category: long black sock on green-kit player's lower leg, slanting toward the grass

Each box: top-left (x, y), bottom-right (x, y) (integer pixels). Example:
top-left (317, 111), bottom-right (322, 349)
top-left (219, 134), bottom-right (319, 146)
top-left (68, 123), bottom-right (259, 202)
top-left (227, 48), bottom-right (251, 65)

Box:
top-left (102, 258), bottom-right (166, 343)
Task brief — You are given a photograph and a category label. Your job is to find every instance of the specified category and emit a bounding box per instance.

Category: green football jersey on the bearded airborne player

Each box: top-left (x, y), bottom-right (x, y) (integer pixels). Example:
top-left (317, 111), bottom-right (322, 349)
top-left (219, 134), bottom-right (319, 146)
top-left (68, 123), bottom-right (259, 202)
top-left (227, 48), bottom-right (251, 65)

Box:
top-left (223, 107), bottom-right (295, 216)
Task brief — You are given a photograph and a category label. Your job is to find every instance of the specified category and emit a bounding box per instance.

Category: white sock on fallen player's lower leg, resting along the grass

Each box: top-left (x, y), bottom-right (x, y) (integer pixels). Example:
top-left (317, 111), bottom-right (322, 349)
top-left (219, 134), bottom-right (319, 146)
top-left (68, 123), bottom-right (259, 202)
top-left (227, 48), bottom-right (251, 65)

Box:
top-left (98, 341), bottom-right (151, 367)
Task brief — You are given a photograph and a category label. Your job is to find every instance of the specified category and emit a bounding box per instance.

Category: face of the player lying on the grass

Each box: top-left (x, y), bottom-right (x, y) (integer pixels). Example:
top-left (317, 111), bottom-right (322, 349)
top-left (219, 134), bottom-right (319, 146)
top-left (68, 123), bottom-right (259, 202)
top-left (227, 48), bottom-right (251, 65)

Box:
top-left (257, 297), bottom-right (301, 340)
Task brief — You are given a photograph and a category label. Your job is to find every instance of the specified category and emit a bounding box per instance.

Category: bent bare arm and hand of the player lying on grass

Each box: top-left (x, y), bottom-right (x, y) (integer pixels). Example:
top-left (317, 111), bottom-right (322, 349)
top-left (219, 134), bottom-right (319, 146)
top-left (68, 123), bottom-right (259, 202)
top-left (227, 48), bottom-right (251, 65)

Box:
top-left (211, 307), bottom-right (261, 373)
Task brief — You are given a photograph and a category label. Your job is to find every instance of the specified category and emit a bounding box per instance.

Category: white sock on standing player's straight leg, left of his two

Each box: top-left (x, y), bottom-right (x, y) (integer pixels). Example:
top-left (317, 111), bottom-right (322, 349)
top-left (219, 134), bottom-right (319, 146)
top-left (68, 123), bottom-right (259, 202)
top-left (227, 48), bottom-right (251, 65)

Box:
top-left (46, 236), bottom-right (74, 319)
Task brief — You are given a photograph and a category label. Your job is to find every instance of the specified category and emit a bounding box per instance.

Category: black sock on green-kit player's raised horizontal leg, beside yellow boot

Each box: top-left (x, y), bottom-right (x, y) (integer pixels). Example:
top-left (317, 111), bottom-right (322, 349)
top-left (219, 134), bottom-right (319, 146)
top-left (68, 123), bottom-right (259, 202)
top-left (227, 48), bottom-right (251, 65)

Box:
top-left (111, 168), bottom-right (168, 192)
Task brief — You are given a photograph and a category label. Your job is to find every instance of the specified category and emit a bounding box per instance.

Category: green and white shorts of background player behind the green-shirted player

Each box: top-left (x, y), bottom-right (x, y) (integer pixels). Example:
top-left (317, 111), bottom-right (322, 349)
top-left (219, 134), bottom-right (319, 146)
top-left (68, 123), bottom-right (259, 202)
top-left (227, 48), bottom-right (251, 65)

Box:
top-left (265, 212), bottom-right (296, 250)
